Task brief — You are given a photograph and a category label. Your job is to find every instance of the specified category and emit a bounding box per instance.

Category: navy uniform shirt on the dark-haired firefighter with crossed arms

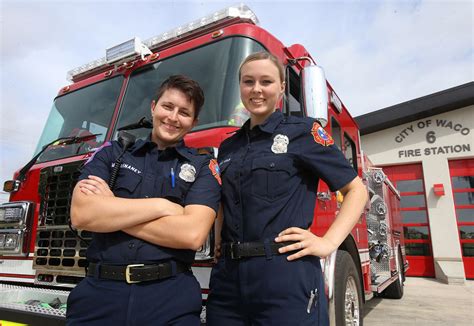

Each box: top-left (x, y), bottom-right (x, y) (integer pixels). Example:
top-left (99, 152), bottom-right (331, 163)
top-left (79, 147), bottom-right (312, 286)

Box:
top-left (79, 140), bottom-right (220, 265)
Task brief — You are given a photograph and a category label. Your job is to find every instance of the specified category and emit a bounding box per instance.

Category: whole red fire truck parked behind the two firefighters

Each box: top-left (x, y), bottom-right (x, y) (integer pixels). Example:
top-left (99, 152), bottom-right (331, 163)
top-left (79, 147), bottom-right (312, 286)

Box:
top-left (0, 5), bottom-right (408, 325)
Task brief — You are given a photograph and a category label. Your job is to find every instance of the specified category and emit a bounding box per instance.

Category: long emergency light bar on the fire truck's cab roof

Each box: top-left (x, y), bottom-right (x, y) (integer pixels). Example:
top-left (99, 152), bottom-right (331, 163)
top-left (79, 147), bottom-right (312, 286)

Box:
top-left (66, 4), bottom-right (259, 82)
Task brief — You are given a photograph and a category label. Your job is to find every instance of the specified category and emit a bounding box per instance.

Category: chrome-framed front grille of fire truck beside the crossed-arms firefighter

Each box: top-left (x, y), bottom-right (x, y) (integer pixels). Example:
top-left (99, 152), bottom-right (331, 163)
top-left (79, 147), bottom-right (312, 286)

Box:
top-left (33, 161), bottom-right (92, 286)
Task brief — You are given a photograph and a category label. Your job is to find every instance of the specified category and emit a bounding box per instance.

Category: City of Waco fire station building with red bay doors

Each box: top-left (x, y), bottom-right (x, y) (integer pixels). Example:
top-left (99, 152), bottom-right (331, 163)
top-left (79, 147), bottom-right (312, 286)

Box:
top-left (356, 82), bottom-right (474, 283)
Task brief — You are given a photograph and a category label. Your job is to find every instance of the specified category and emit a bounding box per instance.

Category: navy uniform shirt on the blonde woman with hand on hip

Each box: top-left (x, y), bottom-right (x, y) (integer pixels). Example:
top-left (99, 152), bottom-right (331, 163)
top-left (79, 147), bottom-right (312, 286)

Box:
top-left (218, 111), bottom-right (357, 242)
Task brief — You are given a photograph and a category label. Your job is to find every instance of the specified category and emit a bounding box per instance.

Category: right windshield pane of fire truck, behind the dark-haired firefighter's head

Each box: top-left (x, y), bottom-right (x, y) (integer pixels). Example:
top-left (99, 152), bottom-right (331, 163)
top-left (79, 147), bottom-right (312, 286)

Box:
top-left (113, 37), bottom-right (263, 138)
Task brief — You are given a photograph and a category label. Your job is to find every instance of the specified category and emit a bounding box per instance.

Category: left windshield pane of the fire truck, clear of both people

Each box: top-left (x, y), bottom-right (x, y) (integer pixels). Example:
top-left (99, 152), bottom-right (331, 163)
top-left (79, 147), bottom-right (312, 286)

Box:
top-left (35, 76), bottom-right (123, 162)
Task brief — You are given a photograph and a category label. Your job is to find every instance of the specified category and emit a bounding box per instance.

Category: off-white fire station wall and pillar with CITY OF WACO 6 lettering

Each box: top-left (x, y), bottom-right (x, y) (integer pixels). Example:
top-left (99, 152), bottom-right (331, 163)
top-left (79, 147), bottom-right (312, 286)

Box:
top-left (362, 106), bottom-right (474, 283)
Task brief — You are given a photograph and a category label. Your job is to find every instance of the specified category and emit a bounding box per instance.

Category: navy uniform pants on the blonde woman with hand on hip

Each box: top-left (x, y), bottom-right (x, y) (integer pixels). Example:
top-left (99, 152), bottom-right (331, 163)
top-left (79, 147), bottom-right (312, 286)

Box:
top-left (206, 255), bottom-right (329, 326)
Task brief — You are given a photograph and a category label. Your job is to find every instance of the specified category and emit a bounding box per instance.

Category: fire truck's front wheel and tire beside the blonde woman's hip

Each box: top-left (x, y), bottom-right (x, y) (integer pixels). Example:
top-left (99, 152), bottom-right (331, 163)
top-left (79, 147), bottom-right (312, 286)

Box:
top-left (334, 250), bottom-right (363, 326)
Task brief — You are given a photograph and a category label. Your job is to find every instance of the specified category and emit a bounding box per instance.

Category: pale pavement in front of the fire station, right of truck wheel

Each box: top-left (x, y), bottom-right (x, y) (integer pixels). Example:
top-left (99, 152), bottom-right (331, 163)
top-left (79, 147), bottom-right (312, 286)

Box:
top-left (364, 277), bottom-right (474, 326)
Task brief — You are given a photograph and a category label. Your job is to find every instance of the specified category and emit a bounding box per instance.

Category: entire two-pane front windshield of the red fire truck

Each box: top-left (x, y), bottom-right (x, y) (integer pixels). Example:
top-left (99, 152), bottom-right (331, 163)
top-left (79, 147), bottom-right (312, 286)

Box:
top-left (31, 36), bottom-right (263, 162)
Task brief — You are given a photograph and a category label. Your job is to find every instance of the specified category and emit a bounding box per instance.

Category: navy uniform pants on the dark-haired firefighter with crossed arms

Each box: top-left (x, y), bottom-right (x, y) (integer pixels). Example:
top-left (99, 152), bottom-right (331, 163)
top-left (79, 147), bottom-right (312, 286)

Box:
top-left (67, 272), bottom-right (202, 326)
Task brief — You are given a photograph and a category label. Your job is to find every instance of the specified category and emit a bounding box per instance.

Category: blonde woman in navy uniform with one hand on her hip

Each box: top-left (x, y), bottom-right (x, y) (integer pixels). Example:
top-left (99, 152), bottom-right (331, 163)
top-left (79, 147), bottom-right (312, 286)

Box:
top-left (207, 52), bottom-right (367, 326)
